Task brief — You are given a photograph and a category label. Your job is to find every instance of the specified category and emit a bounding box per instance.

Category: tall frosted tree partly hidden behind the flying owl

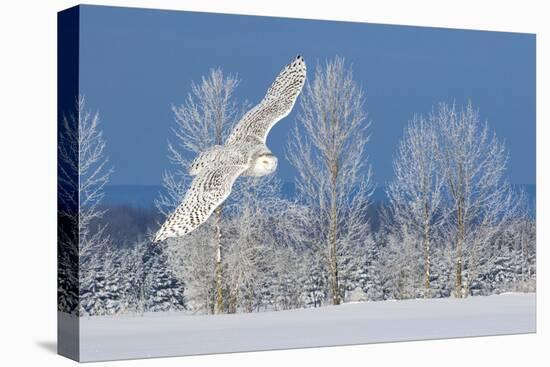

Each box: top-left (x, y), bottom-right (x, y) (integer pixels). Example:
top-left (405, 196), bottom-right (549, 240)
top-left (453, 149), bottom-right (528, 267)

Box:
top-left (156, 69), bottom-right (239, 313)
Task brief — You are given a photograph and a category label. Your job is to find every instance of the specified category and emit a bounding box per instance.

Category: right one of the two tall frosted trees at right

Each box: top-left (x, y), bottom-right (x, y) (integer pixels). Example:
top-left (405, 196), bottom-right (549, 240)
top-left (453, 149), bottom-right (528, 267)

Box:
top-left (433, 103), bottom-right (512, 297)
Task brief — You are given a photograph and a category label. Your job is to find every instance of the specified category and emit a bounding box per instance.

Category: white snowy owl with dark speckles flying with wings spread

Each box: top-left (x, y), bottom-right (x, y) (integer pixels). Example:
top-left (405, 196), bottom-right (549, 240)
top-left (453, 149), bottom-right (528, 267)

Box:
top-left (154, 56), bottom-right (306, 242)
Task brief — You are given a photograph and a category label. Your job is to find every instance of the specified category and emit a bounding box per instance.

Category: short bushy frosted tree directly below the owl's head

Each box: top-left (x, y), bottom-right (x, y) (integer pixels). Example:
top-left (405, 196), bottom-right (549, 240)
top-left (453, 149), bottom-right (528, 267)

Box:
top-left (227, 176), bottom-right (312, 312)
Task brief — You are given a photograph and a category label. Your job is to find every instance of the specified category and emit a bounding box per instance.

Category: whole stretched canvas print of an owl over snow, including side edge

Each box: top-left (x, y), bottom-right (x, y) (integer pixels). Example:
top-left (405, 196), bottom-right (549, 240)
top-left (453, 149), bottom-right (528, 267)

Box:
top-left (58, 5), bottom-right (536, 361)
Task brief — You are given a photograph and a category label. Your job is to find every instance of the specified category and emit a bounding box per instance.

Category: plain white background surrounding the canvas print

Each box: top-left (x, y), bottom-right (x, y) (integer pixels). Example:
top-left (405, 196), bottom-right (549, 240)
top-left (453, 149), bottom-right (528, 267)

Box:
top-left (0, 0), bottom-right (550, 367)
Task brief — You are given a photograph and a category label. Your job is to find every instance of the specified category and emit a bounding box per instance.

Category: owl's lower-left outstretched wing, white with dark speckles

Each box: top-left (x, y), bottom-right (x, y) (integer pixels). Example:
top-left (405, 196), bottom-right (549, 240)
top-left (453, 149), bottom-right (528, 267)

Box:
top-left (153, 165), bottom-right (248, 242)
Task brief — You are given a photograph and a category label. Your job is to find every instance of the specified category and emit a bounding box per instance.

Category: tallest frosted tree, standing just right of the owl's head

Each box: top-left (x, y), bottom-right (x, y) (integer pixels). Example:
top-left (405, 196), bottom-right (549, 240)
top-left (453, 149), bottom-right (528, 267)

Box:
top-left (286, 58), bottom-right (372, 305)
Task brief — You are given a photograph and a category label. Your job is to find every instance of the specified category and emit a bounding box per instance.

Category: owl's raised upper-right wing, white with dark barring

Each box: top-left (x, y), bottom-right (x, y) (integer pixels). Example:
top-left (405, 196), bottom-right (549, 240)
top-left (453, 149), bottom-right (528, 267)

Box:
top-left (226, 56), bottom-right (306, 145)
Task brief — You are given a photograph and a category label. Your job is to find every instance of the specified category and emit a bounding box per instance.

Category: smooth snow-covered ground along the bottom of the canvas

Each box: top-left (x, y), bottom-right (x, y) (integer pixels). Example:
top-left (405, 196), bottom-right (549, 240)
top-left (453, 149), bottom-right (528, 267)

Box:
top-left (59, 293), bottom-right (536, 361)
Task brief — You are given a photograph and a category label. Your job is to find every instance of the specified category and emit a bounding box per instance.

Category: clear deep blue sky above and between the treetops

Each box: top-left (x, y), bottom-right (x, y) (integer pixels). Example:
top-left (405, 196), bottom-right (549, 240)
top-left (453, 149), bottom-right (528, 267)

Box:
top-left (80, 6), bottom-right (535, 186)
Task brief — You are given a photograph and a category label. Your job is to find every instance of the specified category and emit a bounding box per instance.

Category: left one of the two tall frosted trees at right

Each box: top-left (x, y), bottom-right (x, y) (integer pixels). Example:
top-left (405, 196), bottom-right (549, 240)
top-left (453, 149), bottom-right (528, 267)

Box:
top-left (386, 115), bottom-right (445, 298)
